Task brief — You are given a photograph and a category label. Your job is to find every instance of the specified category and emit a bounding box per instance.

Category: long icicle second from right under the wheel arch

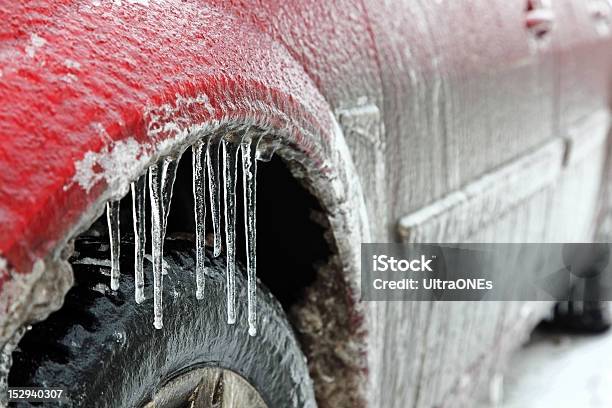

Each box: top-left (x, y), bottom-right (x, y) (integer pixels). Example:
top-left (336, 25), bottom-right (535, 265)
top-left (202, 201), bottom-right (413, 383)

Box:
top-left (222, 139), bottom-right (239, 324)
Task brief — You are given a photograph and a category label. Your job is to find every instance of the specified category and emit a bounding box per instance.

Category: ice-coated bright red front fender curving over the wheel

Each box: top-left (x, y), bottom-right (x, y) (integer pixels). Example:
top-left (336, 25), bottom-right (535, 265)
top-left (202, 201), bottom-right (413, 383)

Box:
top-left (0, 1), bottom-right (350, 278)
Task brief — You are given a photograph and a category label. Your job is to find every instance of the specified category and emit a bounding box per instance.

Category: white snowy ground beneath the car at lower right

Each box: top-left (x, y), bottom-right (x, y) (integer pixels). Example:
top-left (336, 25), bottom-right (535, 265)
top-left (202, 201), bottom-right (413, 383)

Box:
top-left (500, 312), bottom-right (612, 408)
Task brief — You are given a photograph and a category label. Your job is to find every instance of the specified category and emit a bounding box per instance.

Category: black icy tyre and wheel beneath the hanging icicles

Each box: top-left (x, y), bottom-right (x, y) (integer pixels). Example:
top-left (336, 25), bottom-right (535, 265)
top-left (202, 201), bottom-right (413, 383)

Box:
top-left (9, 237), bottom-right (315, 408)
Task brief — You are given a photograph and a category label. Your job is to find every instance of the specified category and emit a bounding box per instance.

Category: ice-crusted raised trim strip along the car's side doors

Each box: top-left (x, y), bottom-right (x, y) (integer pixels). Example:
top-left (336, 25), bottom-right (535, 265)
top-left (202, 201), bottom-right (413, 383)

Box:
top-left (399, 111), bottom-right (610, 242)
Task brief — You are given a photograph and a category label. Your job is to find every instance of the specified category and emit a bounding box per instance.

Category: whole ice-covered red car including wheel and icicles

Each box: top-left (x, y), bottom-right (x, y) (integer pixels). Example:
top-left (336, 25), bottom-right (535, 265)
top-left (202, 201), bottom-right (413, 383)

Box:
top-left (0, 0), bottom-right (612, 408)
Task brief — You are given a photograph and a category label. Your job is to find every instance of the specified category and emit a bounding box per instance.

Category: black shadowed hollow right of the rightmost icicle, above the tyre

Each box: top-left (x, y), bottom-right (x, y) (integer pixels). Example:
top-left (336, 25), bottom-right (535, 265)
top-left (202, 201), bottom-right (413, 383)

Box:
top-left (249, 156), bottom-right (332, 310)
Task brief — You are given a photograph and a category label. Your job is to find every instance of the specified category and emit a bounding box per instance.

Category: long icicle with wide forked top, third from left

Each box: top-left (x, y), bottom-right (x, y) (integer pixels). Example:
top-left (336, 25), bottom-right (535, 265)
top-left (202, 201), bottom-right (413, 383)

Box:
top-left (149, 157), bottom-right (178, 329)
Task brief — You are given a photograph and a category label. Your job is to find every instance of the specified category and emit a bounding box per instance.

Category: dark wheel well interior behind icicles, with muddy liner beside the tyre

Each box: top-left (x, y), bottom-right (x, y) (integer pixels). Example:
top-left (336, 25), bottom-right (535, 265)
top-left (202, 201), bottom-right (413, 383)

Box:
top-left (11, 139), bottom-right (350, 404)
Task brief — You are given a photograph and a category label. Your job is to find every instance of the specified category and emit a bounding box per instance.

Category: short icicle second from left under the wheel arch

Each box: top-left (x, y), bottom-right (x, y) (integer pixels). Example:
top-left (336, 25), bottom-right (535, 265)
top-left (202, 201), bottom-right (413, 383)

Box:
top-left (132, 175), bottom-right (147, 303)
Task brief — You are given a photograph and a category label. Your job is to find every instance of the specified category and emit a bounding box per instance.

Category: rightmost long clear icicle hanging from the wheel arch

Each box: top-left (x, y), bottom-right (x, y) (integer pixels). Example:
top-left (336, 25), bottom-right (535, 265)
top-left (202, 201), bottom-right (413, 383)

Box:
top-left (240, 136), bottom-right (260, 336)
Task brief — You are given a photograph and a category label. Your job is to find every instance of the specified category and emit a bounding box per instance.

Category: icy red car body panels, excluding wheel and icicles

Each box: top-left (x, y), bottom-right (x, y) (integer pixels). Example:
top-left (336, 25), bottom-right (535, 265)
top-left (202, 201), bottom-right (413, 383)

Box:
top-left (0, 0), bottom-right (612, 407)
